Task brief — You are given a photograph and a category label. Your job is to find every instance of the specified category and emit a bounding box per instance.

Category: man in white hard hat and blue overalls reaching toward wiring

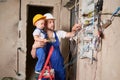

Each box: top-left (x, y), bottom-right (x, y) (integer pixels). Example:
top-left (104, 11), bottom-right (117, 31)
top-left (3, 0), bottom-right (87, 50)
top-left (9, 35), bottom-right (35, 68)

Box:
top-left (31, 13), bottom-right (81, 80)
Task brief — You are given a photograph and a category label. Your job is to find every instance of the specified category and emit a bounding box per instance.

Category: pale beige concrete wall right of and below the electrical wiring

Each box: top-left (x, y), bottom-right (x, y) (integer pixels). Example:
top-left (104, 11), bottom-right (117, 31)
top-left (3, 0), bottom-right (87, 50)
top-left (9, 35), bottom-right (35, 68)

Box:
top-left (77, 0), bottom-right (120, 80)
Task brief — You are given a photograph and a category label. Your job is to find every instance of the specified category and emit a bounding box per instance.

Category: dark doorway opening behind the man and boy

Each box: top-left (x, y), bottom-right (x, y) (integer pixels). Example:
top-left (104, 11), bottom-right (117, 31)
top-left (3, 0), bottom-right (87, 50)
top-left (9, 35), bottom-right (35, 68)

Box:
top-left (26, 5), bottom-right (53, 80)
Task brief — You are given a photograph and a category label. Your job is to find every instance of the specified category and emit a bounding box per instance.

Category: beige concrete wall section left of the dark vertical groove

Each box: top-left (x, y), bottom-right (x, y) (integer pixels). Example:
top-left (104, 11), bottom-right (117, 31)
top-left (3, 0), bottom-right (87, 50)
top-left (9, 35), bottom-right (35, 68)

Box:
top-left (0, 0), bottom-right (19, 77)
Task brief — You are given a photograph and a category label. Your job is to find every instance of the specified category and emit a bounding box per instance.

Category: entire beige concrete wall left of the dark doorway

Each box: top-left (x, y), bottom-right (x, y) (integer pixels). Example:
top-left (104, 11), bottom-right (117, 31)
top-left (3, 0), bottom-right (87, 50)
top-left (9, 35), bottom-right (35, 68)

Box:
top-left (0, 0), bottom-right (26, 78)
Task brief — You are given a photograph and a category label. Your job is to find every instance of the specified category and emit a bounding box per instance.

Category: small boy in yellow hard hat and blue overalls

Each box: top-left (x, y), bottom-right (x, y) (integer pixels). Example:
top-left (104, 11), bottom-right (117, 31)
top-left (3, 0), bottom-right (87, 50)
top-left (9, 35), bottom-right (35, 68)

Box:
top-left (33, 14), bottom-right (47, 73)
